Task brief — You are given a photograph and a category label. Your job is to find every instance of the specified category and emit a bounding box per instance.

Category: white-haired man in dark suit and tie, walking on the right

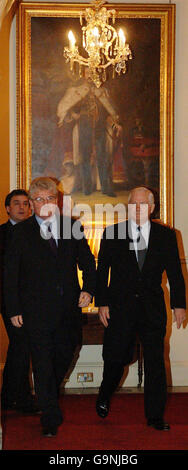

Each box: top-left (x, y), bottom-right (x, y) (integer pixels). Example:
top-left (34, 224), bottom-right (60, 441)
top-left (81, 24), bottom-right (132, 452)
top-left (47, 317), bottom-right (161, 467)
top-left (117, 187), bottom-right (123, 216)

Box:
top-left (96, 188), bottom-right (185, 430)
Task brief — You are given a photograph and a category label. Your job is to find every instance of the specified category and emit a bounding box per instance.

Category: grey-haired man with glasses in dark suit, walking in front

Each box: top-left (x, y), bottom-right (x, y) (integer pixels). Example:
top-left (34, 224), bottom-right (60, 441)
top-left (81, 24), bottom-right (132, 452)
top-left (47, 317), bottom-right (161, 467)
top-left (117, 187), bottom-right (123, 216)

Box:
top-left (5, 178), bottom-right (96, 436)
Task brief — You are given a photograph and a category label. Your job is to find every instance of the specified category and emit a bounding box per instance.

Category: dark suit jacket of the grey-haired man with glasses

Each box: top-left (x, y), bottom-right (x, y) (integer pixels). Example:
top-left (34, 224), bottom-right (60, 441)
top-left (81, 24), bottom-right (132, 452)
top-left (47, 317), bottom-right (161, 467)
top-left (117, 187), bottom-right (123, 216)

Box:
top-left (4, 216), bottom-right (96, 336)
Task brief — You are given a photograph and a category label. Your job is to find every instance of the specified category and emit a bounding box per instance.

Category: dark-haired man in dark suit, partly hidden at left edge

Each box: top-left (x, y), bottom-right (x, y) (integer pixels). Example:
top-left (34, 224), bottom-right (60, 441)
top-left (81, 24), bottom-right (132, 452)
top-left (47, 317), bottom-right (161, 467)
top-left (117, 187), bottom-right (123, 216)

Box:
top-left (0, 189), bottom-right (37, 413)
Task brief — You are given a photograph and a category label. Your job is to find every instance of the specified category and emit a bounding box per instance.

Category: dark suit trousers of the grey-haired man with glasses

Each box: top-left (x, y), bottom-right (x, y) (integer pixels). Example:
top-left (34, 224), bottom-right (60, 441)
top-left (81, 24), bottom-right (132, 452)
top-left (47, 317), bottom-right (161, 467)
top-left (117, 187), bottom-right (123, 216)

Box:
top-left (28, 324), bottom-right (74, 426)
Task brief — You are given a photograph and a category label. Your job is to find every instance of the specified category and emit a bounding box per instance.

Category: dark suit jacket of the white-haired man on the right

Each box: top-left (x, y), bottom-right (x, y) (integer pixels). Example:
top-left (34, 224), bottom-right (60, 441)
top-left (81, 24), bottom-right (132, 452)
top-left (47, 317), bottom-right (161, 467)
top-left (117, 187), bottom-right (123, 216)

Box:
top-left (96, 222), bottom-right (185, 358)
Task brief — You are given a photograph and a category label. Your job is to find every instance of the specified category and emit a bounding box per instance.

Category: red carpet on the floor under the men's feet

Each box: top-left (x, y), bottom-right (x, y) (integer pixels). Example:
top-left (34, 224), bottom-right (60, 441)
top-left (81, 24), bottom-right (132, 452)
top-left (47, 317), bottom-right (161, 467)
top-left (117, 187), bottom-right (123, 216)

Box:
top-left (2, 393), bottom-right (188, 451)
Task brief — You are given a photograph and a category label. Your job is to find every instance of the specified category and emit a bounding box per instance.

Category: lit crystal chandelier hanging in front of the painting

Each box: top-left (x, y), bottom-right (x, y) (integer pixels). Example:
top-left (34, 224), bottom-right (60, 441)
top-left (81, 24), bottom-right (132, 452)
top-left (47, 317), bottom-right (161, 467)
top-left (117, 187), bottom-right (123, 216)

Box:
top-left (64, 0), bottom-right (132, 88)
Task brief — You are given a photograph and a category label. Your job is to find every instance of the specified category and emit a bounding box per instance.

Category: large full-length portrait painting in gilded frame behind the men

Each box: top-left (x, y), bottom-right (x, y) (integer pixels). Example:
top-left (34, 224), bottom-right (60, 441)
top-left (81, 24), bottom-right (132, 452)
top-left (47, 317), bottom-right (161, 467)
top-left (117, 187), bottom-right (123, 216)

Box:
top-left (17, 3), bottom-right (175, 237)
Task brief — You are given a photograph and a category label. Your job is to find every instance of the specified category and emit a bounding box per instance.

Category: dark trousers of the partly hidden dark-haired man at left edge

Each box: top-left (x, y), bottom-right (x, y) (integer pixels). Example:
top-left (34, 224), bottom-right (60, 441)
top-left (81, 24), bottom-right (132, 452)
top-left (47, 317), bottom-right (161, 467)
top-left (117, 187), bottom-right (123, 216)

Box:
top-left (1, 314), bottom-right (31, 407)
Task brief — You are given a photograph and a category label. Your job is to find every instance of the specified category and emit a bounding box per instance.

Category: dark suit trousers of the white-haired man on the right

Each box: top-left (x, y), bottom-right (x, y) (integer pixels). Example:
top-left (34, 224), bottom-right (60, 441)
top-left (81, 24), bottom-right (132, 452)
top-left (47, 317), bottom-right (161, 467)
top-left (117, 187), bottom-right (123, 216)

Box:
top-left (100, 302), bottom-right (167, 420)
